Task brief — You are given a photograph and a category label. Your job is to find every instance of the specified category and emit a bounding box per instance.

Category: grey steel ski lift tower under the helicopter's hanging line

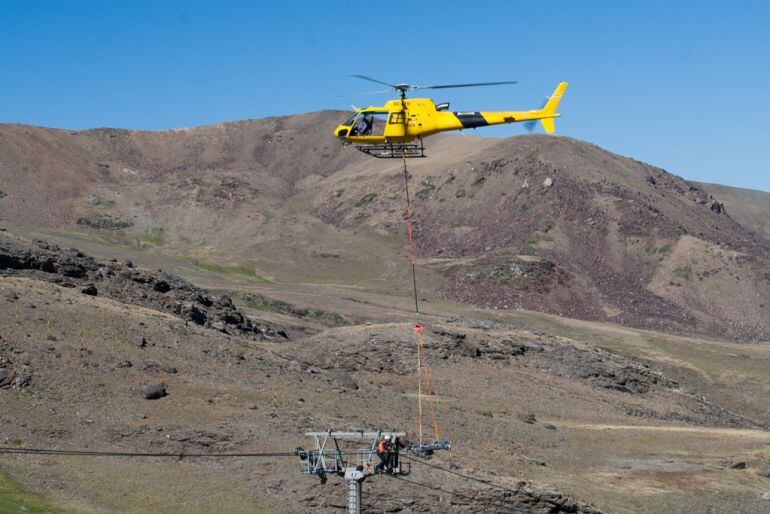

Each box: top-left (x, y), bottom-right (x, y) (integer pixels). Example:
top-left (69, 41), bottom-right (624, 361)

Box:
top-left (294, 430), bottom-right (452, 514)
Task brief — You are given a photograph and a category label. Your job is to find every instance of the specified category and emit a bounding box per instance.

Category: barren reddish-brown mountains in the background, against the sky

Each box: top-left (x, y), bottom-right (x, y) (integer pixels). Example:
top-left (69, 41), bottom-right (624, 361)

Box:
top-left (0, 116), bottom-right (770, 341)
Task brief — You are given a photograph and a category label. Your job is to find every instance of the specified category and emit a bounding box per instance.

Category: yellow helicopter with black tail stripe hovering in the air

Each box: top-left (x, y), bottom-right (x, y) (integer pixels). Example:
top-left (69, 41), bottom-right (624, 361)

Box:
top-left (334, 75), bottom-right (567, 158)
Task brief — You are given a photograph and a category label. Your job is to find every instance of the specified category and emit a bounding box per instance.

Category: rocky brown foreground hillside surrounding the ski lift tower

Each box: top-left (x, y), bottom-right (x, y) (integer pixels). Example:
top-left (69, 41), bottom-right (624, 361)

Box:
top-left (0, 233), bottom-right (770, 508)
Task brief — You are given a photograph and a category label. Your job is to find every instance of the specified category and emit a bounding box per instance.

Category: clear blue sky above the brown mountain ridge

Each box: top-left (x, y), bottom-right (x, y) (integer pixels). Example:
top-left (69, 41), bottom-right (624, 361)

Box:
top-left (0, 0), bottom-right (770, 191)
